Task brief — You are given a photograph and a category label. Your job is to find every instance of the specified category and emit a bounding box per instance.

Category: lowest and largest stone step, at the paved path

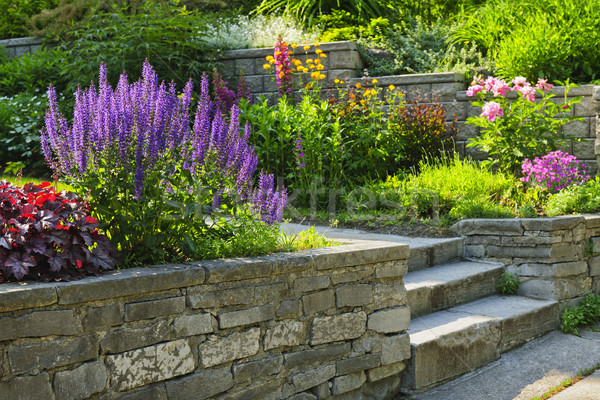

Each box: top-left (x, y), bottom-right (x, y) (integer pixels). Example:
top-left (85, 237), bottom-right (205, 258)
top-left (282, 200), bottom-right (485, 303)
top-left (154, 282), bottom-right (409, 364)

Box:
top-left (402, 296), bottom-right (559, 393)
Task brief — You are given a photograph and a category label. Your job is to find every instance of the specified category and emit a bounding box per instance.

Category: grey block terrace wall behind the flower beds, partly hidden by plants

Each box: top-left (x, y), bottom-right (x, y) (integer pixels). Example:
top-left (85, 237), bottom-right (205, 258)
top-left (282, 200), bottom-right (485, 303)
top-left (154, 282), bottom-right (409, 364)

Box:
top-left (222, 41), bottom-right (600, 174)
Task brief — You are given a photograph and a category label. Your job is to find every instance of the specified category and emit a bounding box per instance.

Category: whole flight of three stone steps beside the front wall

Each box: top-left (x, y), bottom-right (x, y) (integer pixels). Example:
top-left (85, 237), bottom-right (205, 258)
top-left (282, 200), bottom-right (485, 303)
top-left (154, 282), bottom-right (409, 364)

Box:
top-left (402, 238), bottom-right (559, 394)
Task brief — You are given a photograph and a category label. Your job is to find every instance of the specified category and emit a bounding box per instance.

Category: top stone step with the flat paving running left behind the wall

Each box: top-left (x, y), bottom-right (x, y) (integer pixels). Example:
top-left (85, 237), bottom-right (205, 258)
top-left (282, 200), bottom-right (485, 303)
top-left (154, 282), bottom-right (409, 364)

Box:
top-left (282, 223), bottom-right (463, 271)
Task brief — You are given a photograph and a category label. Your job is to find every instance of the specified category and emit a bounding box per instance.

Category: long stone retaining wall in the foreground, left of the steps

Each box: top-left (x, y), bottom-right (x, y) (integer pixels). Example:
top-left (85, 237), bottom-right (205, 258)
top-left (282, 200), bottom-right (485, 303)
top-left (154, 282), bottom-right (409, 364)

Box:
top-left (0, 242), bottom-right (410, 400)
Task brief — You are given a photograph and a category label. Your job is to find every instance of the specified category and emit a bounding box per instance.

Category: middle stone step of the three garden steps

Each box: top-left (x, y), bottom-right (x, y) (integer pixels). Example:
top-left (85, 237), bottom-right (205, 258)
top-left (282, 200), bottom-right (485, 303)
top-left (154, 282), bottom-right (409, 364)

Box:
top-left (403, 261), bottom-right (504, 318)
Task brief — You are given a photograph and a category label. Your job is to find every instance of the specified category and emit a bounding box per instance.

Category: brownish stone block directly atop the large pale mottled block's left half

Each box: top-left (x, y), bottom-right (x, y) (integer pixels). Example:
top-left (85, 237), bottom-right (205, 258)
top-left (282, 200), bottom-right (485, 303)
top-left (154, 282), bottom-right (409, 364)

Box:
top-left (100, 321), bottom-right (171, 353)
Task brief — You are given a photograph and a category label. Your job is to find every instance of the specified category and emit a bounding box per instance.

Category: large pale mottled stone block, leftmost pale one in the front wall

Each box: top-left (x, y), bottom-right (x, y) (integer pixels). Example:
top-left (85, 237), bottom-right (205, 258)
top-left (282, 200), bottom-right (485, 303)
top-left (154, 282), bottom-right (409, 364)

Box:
top-left (106, 339), bottom-right (196, 392)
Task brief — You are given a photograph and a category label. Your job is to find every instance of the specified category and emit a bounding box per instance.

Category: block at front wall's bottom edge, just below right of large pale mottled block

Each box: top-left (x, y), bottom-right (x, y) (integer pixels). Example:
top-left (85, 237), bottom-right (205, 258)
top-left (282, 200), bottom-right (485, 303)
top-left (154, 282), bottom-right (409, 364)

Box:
top-left (166, 367), bottom-right (233, 400)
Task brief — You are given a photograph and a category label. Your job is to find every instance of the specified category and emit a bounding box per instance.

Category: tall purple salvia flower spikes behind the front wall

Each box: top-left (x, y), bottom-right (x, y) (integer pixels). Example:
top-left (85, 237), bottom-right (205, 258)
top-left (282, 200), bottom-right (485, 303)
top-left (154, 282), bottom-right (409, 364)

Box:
top-left (41, 61), bottom-right (287, 223)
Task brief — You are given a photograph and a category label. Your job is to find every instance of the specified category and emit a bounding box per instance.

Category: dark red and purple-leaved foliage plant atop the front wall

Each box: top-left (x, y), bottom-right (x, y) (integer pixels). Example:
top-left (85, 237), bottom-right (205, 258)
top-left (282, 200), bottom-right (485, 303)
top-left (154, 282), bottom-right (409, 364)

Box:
top-left (0, 180), bottom-right (118, 282)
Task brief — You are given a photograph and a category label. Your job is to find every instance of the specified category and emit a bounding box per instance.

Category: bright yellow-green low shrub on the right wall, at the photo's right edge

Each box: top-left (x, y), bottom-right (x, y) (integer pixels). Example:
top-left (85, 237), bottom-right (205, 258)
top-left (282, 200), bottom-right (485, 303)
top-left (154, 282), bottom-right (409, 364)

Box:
top-left (546, 177), bottom-right (600, 216)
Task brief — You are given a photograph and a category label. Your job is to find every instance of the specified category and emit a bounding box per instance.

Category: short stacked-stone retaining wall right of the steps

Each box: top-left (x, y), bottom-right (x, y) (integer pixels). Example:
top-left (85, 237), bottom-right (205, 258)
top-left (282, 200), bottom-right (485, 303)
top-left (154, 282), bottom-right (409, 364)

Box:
top-left (453, 215), bottom-right (600, 304)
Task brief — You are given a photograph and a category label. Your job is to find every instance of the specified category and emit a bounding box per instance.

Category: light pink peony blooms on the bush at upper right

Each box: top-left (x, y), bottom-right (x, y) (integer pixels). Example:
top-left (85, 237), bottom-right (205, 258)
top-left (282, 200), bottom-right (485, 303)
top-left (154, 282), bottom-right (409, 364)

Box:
top-left (467, 76), bottom-right (553, 122)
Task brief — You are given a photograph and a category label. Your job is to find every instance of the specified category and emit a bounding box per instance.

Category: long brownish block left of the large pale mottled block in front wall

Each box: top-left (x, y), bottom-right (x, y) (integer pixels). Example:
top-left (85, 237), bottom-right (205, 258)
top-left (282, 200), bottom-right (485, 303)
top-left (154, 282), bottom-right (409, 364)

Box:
top-left (8, 335), bottom-right (98, 374)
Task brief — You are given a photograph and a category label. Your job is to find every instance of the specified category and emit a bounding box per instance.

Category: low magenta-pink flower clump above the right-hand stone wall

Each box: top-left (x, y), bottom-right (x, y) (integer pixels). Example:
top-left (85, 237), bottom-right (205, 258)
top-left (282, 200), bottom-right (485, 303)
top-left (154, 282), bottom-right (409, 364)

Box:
top-left (521, 150), bottom-right (590, 193)
